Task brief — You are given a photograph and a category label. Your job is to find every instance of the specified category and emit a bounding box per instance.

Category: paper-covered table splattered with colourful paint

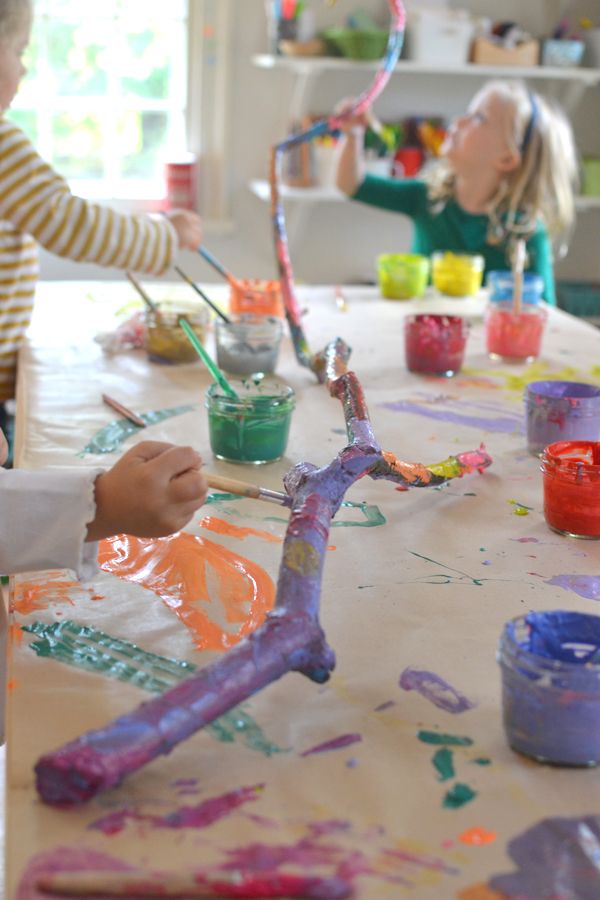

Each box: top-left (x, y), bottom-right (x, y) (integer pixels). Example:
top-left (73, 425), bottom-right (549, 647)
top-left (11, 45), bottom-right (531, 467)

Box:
top-left (6, 283), bottom-right (600, 900)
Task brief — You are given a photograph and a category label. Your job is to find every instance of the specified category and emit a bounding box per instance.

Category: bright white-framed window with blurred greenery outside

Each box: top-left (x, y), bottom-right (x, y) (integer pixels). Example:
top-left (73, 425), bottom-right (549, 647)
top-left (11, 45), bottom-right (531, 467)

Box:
top-left (9, 0), bottom-right (229, 221)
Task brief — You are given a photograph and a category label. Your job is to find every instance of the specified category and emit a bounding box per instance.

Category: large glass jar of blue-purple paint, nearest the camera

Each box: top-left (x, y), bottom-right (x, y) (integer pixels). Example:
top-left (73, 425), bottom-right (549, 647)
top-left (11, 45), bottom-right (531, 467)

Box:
top-left (498, 611), bottom-right (600, 766)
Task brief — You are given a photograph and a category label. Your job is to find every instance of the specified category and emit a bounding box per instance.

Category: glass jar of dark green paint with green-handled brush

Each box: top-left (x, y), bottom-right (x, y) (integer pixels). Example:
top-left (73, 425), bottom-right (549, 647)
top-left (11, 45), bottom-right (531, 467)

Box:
top-left (206, 379), bottom-right (295, 465)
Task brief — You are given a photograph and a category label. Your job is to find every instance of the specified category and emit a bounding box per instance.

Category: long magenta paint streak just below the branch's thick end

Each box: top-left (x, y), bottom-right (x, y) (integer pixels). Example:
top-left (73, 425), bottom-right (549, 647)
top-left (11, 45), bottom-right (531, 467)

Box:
top-left (88, 784), bottom-right (264, 835)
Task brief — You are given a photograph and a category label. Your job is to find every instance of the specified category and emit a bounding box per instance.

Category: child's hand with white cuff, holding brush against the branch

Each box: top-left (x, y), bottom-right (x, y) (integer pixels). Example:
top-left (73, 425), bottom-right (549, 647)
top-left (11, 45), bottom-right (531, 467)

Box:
top-left (86, 441), bottom-right (208, 541)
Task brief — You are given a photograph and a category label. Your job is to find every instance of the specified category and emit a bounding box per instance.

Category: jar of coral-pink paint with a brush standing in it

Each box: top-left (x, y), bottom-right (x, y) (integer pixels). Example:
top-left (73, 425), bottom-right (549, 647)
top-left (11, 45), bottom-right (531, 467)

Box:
top-left (485, 300), bottom-right (548, 363)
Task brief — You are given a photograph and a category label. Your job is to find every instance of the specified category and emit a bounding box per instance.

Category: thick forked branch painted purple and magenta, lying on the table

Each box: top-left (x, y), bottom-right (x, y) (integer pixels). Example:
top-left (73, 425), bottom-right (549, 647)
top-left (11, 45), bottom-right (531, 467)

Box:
top-left (35, 341), bottom-right (490, 807)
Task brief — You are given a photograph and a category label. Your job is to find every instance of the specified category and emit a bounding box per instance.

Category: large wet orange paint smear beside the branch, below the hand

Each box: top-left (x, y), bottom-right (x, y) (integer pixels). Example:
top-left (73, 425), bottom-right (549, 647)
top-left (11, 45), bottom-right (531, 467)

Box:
top-left (98, 532), bottom-right (275, 650)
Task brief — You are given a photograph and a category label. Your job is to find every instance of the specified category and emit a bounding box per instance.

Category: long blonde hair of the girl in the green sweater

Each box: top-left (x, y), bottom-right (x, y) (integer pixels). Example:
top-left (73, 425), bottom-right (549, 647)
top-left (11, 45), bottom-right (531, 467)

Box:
top-left (424, 80), bottom-right (578, 253)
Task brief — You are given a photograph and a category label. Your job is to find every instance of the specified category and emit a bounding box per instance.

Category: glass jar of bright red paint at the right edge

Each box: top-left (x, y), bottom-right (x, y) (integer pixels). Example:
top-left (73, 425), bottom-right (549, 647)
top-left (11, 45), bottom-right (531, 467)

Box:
top-left (540, 441), bottom-right (600, 540)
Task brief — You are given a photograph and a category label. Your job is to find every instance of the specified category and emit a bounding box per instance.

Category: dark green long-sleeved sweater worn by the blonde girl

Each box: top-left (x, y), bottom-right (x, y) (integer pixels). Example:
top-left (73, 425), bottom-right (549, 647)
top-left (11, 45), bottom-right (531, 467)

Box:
top-left (352, 175), bottom-right (556, 306)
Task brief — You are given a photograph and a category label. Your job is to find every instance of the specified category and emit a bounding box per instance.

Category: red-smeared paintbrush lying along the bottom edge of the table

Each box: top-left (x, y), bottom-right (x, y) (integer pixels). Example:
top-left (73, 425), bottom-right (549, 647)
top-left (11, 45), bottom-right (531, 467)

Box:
top-left (35, 870), bottom-right (350, 900)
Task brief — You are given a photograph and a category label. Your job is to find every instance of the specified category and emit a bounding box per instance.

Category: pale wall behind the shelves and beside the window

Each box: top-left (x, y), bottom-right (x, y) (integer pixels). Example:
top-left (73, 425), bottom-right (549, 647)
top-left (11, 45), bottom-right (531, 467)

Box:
top-left (42, 0), bottom-right (600, 283)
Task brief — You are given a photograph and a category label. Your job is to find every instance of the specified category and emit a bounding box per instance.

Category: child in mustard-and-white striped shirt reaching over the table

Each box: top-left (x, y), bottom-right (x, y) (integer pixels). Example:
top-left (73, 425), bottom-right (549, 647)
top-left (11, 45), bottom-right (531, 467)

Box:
top-left (0, 0), bottom-right (202, 418)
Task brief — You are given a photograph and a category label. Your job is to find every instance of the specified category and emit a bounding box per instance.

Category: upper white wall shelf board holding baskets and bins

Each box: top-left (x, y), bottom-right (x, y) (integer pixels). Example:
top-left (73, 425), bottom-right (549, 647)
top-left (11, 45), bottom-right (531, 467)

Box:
top-left (252, 53), bottom-right (600, 87)
